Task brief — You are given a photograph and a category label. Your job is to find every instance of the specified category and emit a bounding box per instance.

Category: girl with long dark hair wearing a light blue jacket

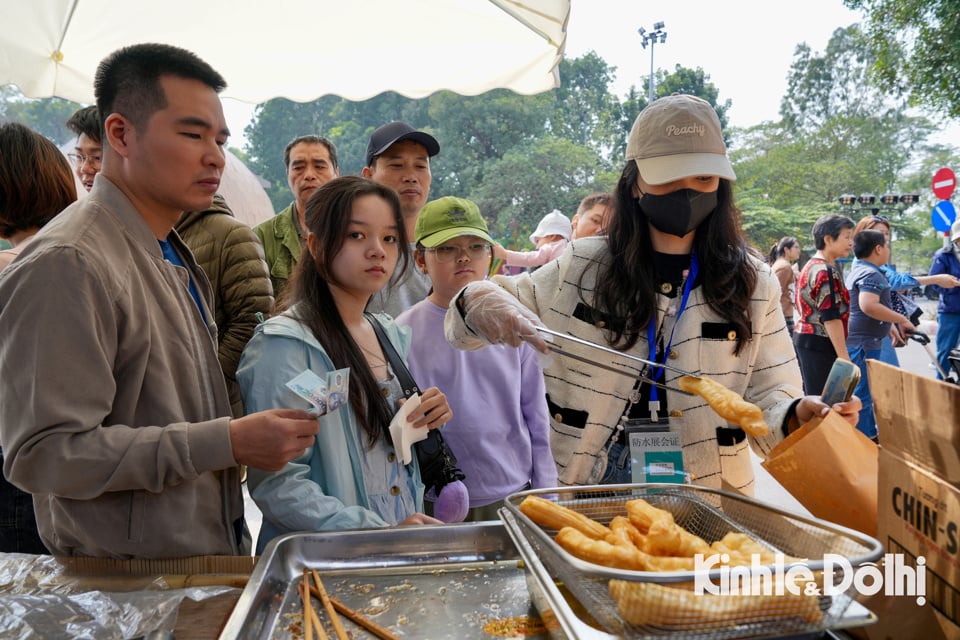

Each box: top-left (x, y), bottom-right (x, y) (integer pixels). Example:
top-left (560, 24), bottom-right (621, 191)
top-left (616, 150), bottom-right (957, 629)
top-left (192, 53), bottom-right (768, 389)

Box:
top-left (237, 177), bottom-right (451, 553)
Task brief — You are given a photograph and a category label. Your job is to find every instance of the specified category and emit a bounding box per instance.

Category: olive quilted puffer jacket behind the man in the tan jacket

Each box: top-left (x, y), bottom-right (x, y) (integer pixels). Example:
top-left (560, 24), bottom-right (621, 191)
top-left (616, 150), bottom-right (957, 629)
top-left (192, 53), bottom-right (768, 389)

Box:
top-left (174, 193), bottom-right (273, 418)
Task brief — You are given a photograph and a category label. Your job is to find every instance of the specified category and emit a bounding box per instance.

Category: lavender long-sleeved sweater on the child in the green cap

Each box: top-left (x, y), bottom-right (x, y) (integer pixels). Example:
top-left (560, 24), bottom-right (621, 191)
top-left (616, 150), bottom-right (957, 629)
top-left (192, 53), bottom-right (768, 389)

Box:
top-left (397, 300), bottom-right (557, 508)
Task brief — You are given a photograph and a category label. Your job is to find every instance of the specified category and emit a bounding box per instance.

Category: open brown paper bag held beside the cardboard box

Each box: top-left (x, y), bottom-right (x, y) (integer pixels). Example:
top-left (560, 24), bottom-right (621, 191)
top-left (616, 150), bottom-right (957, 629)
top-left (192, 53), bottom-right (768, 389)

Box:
top-left (762, 410), bottom-right (879, 536)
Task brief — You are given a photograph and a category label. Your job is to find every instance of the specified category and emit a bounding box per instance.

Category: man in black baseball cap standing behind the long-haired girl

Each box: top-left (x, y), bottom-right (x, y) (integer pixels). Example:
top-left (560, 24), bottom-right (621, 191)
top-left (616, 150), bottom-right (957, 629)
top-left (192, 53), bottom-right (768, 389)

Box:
top-left (361, 122), bottom-right (440, 317)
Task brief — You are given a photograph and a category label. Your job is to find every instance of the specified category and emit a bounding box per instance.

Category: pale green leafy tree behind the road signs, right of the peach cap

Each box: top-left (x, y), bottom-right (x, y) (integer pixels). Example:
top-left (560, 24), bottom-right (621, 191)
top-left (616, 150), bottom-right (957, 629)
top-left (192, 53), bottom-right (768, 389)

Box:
top-left (731, 25), bottom-right (932, 262)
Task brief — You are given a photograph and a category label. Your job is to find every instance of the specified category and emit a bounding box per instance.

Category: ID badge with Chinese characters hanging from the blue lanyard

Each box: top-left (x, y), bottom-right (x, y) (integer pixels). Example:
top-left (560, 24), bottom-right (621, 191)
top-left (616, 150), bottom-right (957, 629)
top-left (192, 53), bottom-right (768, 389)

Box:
top-left (626, 422), bottom-right (689, 484)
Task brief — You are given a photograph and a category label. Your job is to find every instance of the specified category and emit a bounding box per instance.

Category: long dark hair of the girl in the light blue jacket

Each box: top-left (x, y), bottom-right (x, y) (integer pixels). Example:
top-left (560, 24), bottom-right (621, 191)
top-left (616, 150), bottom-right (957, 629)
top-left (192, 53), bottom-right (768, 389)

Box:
top-left (279, 176), bottom-right (410, 445)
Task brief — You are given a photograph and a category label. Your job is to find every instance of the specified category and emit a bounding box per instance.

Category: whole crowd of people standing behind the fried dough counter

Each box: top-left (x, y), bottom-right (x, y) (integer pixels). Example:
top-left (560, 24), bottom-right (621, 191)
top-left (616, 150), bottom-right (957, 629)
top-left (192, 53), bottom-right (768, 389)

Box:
top-left (0, 44), bottom-right (960, 558)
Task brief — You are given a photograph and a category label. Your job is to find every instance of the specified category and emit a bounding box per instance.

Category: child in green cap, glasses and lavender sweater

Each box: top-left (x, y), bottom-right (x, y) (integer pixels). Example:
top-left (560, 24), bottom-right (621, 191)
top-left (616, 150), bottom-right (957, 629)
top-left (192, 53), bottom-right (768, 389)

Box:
top-left (397, 197), bottom-right (557, 521)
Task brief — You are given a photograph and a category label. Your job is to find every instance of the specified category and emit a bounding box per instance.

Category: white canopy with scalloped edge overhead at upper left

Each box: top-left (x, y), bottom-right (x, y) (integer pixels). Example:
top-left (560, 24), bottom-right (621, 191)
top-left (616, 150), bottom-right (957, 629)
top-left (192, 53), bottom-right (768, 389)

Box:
top-left (0, 0), bottom-right (570, 104)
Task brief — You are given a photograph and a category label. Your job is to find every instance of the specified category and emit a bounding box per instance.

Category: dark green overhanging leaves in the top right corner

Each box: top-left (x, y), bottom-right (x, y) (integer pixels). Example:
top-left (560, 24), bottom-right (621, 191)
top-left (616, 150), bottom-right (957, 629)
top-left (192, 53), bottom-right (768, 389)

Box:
top-left (843, 0), bottom-right (960, 118)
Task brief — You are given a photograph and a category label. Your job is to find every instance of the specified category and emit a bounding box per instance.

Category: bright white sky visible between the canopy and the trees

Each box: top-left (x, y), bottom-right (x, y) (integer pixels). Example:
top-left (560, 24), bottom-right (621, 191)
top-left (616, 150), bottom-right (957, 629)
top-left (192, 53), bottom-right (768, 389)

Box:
top-left (224, 0), bottom-right (960, 147)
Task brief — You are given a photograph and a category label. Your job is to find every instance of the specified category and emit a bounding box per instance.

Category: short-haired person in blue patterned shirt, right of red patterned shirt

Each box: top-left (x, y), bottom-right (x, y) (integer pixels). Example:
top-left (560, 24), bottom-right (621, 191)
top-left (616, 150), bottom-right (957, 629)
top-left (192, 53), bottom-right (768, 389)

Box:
top-left (846, 229), bottom-right (913, 441)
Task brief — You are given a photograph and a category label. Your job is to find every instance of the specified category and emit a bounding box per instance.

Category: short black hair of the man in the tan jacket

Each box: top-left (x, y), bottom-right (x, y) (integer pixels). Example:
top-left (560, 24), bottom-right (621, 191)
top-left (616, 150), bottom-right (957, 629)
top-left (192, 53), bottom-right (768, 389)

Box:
top-left (93, 43), bottom-right (227, 132)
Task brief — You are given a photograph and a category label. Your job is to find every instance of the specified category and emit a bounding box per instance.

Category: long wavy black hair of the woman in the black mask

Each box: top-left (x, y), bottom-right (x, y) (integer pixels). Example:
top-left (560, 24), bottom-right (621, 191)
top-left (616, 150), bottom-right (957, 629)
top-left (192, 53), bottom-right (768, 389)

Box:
top-left (595, 161), bottom-right (757, 354)
